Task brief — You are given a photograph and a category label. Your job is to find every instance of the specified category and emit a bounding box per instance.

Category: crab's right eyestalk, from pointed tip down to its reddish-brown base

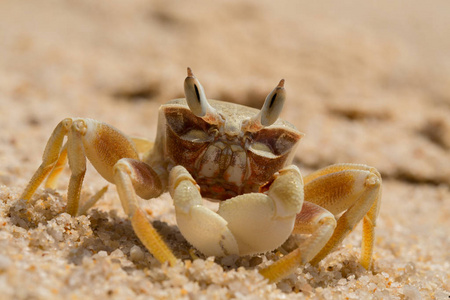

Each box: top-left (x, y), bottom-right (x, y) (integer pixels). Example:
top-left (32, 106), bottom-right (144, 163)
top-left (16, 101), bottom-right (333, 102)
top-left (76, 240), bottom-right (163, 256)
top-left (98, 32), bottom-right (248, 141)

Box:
top-left (243, 79), bottom-right (286, 132)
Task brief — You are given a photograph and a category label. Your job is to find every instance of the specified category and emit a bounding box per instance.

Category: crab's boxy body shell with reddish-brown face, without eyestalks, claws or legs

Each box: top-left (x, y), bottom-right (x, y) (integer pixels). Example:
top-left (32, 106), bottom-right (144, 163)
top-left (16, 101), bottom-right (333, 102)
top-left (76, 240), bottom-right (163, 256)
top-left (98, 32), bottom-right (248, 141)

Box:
top-left (149, 99), bottom-right (303, 200)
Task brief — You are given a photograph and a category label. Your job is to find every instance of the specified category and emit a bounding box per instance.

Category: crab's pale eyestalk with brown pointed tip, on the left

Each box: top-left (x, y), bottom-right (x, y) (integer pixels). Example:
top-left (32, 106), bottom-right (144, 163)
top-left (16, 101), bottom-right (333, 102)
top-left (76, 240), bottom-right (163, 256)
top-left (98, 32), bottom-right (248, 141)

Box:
top-left (184, 67), bottom-right (214, 118)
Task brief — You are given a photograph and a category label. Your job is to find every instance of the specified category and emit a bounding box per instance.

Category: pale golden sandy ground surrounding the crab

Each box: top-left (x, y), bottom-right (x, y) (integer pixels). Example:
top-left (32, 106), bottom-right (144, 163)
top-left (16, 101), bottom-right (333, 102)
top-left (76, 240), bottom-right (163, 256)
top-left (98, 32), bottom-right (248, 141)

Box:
top-left (0, 0), bottom-right (450, 299)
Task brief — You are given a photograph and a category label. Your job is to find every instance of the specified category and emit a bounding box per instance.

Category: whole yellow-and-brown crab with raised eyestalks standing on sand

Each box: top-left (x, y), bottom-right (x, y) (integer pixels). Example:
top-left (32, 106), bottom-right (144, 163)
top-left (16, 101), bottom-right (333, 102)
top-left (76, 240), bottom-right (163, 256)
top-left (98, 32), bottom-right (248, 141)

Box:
top-left (21, 68), bottom-right (381, 282)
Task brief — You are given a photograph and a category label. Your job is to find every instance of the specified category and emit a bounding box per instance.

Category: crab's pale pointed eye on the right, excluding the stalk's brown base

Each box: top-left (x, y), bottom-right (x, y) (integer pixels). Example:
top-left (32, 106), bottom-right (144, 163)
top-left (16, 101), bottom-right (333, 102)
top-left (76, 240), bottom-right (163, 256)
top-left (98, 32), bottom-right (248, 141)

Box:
top-left (260, 79), bottom-right (286, 126)
